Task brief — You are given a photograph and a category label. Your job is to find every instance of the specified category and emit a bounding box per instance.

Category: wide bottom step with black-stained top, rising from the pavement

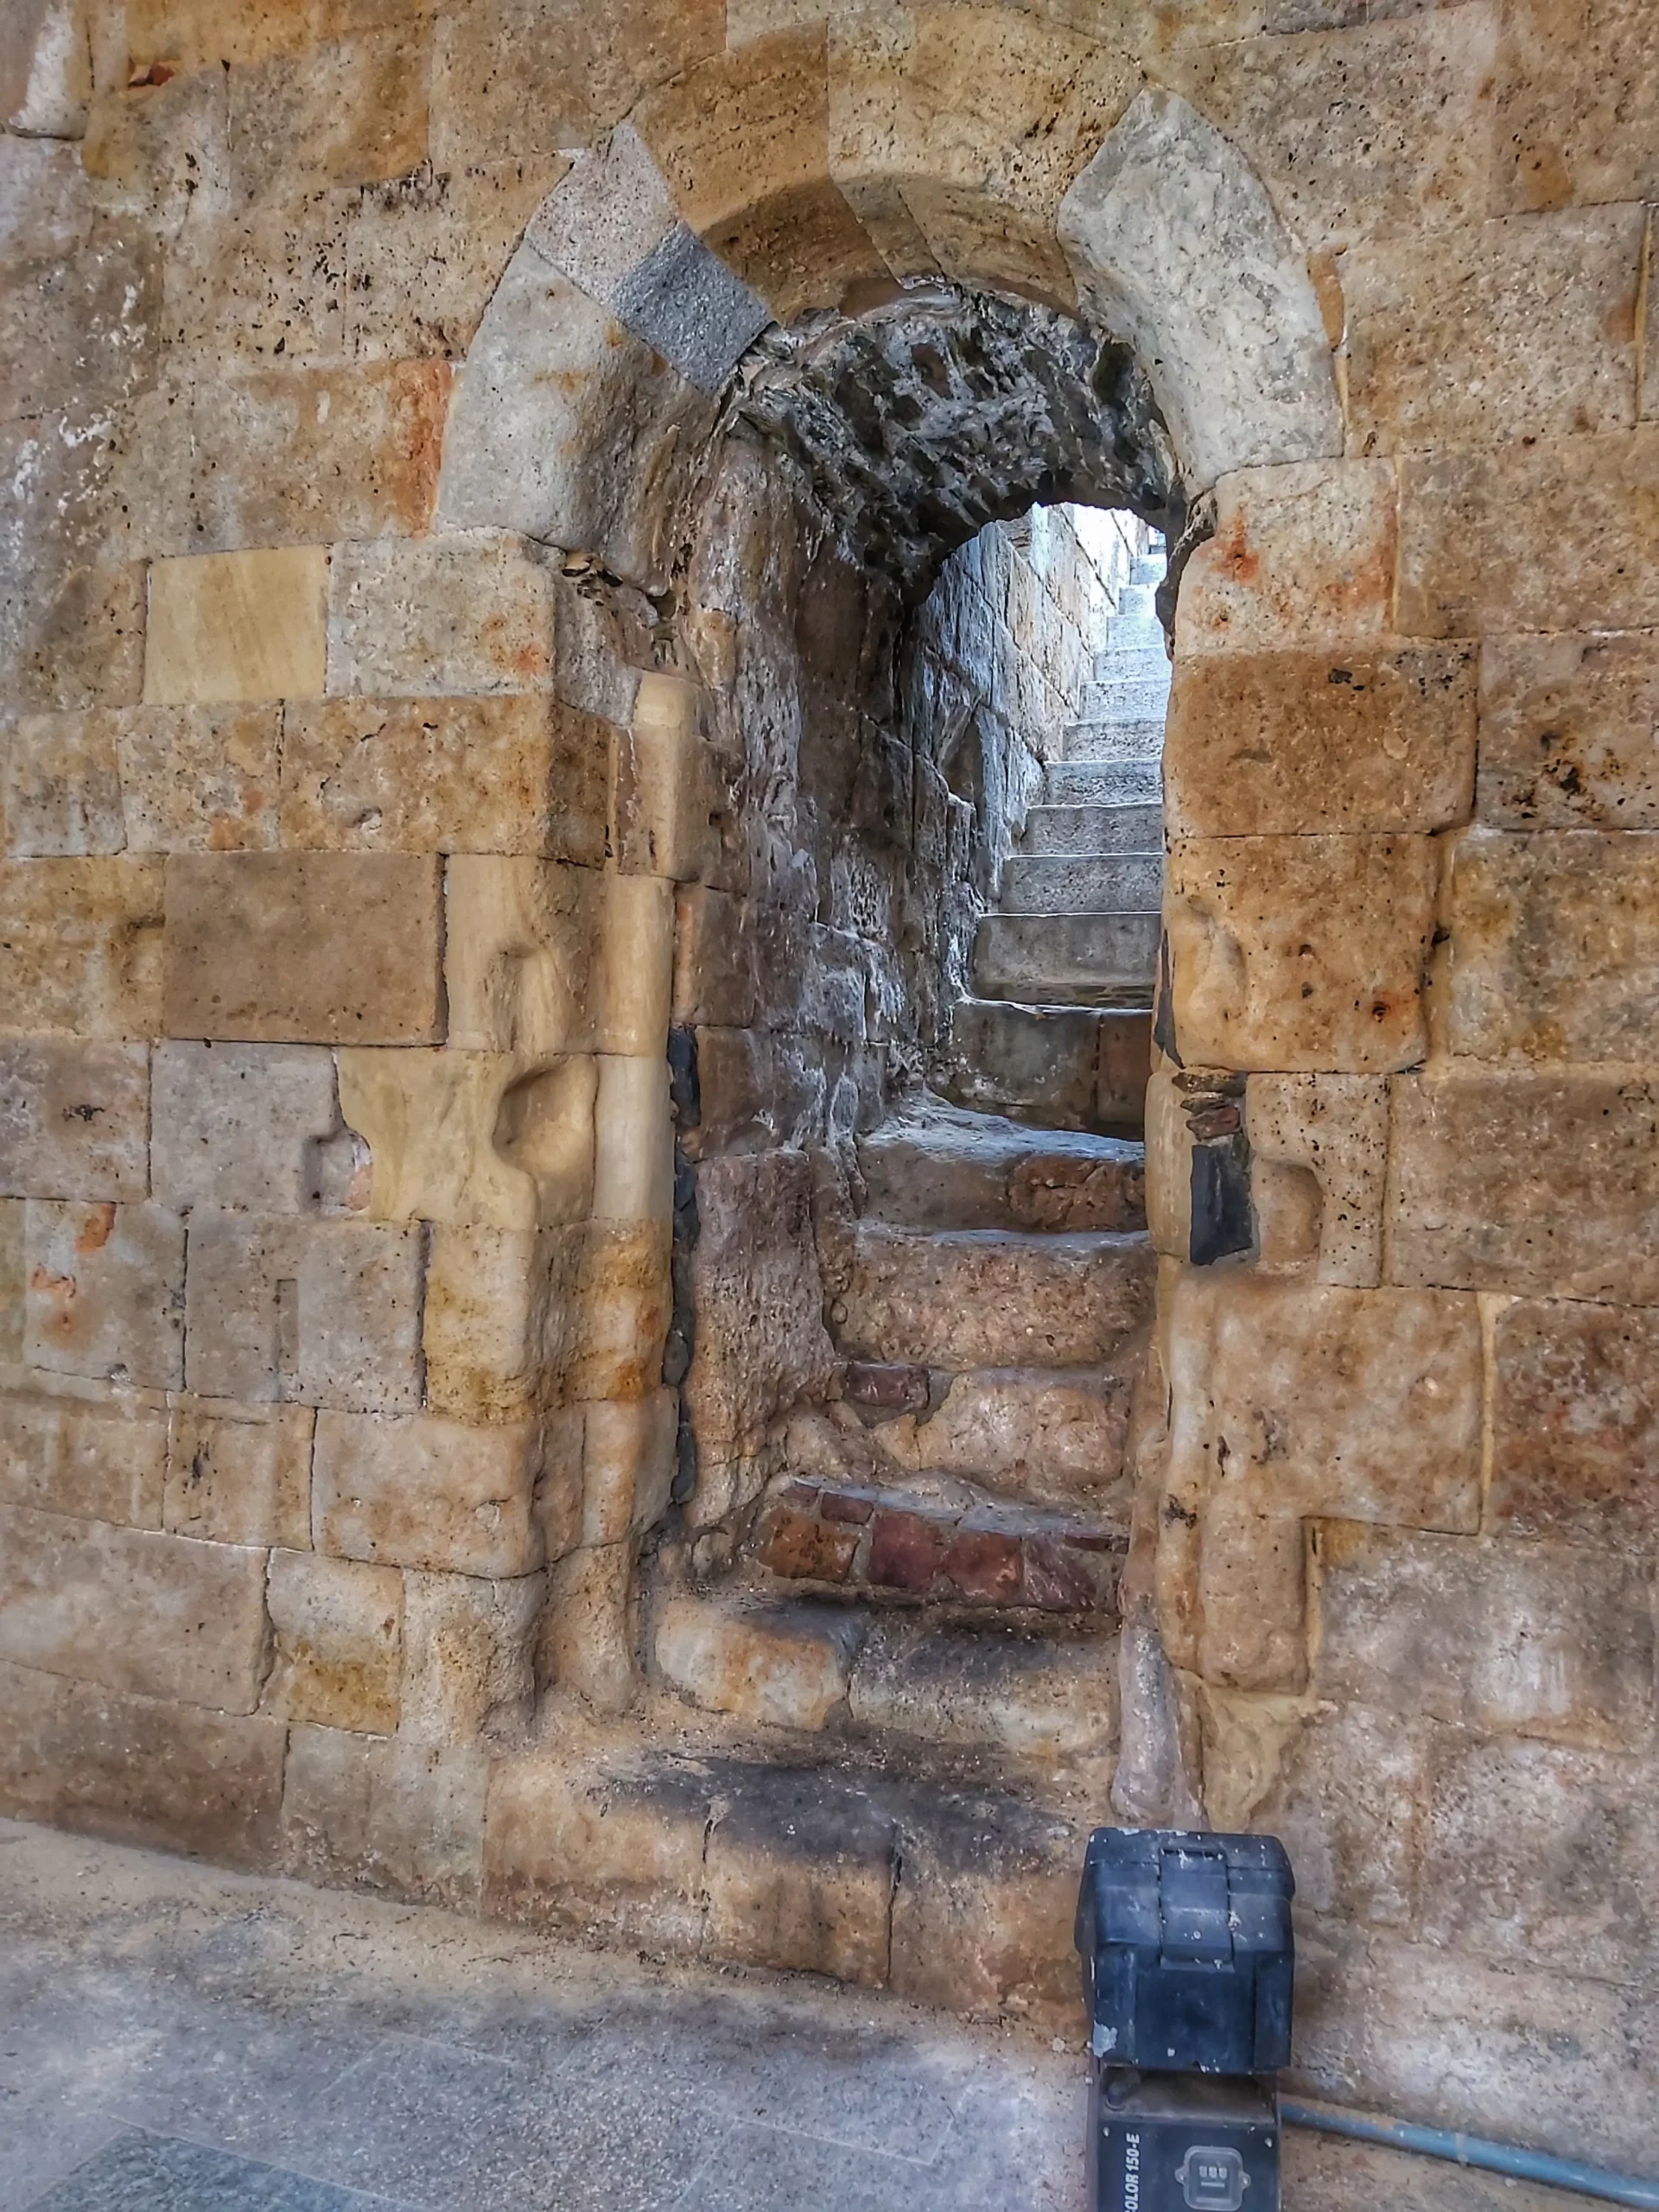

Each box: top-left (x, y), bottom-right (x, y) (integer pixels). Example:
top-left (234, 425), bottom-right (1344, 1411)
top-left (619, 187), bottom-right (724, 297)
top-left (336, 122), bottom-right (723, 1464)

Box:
top-left (480, 1741), bottom-right (1089, 2037)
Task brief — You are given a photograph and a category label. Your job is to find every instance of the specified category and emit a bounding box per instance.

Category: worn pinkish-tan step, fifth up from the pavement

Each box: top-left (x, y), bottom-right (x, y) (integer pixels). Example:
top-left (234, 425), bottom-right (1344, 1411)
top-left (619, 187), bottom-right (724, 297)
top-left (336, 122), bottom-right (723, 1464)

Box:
top-left (832, 1221), bottom-right (1153, 1371)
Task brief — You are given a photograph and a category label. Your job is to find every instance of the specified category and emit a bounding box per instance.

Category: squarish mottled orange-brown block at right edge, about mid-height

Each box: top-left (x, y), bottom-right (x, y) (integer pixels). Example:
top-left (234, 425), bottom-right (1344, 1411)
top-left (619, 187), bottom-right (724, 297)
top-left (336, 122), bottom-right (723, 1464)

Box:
top-left (1446, 830), bottom-right (1659, 1062)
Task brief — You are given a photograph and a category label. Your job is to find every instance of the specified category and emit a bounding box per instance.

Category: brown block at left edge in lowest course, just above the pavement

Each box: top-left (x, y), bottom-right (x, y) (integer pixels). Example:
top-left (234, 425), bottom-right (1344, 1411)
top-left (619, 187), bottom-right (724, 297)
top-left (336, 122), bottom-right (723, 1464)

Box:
top-left (0, 1663), bottom-right (288, 1869)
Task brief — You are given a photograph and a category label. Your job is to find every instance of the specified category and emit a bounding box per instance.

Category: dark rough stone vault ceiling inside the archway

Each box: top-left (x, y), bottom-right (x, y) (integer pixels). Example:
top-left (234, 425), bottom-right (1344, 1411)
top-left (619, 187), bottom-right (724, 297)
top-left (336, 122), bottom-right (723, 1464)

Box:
top-left (732, 283), bottom-right (1184, 600)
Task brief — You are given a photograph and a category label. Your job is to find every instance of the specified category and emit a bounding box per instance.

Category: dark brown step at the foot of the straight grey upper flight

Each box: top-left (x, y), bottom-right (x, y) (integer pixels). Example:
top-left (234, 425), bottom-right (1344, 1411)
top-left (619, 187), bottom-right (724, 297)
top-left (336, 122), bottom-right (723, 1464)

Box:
top-left (938, 998), bottom-right (1153, 1133)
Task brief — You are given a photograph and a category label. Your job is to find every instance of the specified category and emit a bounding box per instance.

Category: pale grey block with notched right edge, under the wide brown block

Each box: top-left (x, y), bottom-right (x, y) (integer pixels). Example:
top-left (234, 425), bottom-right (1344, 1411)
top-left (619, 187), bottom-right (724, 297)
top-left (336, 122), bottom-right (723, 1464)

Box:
top-left (153, 1042), bottom-right (340, 1214)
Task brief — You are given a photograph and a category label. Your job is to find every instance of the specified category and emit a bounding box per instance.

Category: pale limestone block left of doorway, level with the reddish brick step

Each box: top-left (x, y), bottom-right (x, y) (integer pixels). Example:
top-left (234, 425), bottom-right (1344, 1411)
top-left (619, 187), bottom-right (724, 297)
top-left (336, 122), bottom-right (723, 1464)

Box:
top-left (312, 1414), bottom-right (542, 1577)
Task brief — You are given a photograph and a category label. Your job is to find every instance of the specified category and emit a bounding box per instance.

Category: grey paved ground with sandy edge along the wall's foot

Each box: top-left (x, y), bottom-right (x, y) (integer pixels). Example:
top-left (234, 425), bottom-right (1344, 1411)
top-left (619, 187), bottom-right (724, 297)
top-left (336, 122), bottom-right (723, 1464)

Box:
top-left (0, 1821), bottom-right (1610, 2212)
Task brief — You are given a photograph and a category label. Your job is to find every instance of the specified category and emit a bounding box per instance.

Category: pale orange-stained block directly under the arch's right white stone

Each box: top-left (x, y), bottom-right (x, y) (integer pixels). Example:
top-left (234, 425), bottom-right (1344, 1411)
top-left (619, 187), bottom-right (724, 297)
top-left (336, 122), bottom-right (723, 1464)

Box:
top-left (1174, 460), bottom-right (1397, 666)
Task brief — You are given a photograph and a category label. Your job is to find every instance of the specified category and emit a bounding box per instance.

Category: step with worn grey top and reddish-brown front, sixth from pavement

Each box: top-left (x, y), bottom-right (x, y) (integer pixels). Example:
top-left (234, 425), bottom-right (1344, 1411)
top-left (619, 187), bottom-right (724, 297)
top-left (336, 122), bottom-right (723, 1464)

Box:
top-left (858, 1093), bottom-right (1146, 1230)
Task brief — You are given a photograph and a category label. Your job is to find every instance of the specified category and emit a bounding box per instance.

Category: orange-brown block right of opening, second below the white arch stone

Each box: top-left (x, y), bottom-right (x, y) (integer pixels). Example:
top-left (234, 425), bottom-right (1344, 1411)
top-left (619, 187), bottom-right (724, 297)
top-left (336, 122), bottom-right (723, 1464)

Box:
top-left (1164, 646), bottom-right (1484, 836)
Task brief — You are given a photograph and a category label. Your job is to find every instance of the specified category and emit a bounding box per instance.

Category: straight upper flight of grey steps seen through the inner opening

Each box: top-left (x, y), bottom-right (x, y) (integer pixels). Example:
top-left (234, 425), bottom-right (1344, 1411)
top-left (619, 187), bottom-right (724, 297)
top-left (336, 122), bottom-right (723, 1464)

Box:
top-left (949, 550), bottom-right (1170, 1130)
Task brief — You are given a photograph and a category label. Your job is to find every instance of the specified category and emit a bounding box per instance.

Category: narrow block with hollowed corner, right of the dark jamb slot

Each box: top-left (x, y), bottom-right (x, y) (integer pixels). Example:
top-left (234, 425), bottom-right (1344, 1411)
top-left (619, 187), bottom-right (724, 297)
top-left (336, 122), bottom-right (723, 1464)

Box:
top-left (1245, 1075), bottom-right (1389, 1289)
